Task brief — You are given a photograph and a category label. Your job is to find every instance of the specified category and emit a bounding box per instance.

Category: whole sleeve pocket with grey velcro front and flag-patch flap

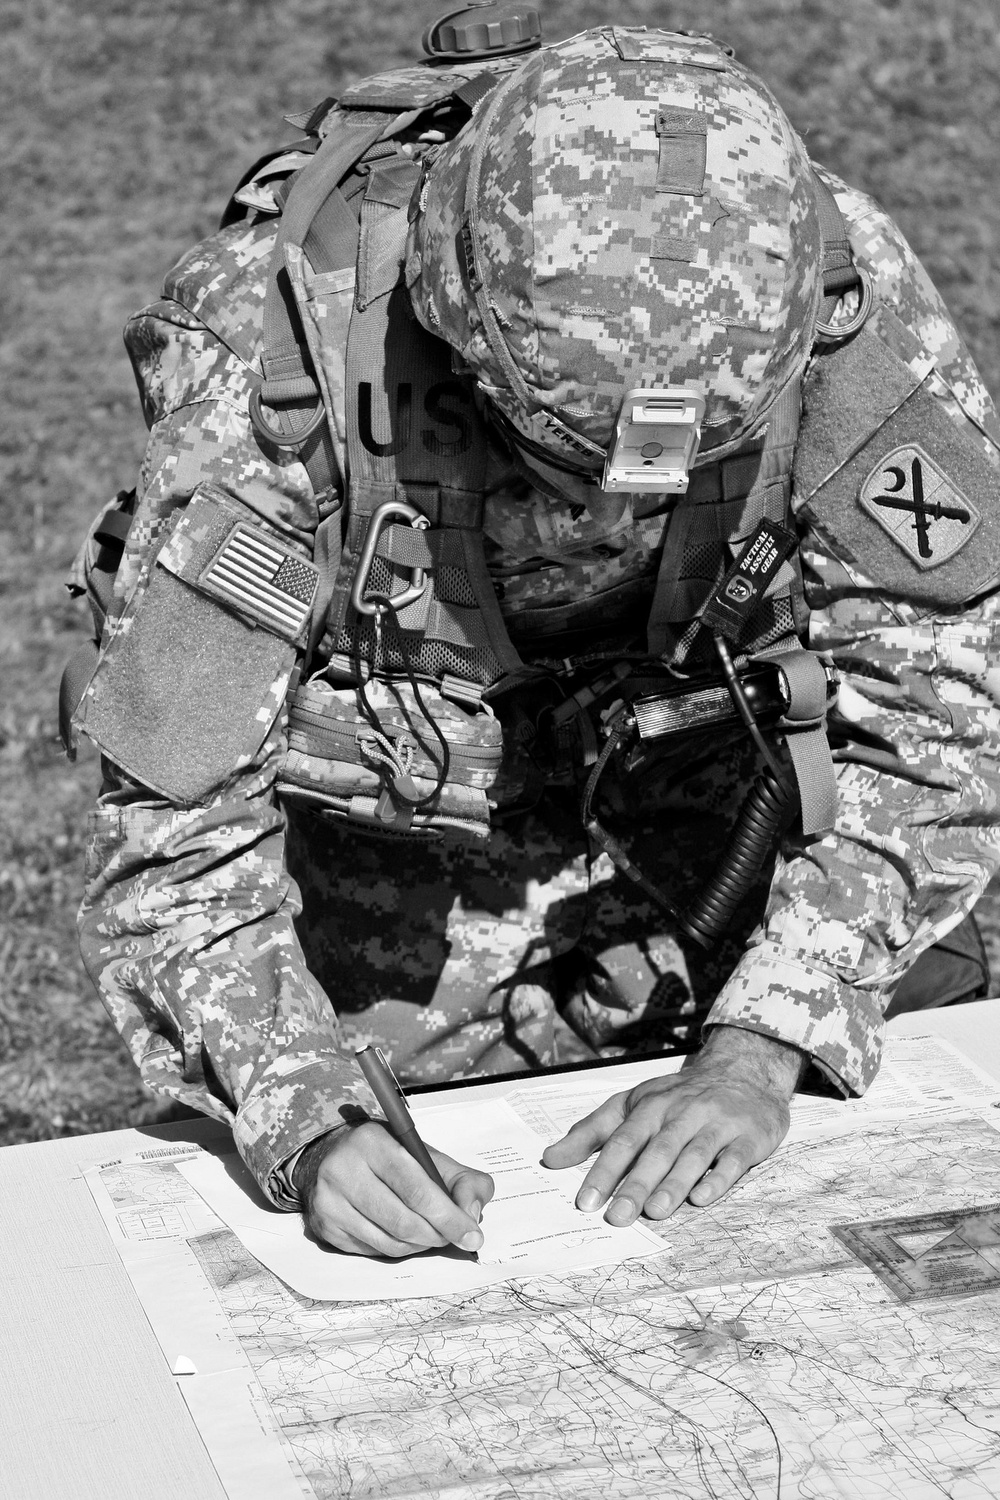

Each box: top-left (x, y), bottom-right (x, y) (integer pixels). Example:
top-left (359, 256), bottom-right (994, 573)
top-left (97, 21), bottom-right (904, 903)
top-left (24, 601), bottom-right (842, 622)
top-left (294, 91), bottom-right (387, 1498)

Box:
top-left (75, 485), bottom-right (318, 804)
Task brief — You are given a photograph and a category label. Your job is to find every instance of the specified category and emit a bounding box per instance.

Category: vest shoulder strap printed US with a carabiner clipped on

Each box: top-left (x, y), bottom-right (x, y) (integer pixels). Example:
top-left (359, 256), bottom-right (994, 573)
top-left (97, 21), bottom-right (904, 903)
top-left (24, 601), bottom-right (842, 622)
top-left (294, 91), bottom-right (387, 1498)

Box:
top-left (325, 155), bottom-right (523, 696)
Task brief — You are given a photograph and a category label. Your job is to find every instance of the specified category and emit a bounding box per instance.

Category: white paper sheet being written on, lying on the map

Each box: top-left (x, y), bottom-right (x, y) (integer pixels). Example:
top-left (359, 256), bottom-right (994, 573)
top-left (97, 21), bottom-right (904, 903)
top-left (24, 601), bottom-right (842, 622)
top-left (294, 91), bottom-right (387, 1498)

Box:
top-left (180, 1097), bottom-right (663, 1302)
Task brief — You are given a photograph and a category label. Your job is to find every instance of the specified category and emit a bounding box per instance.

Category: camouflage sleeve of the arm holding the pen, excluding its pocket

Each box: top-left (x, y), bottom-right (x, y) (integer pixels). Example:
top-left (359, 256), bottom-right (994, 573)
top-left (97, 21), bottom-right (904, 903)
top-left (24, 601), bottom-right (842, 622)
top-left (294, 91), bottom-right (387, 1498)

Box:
top-left (79, 282), bottom-right (370, 1208)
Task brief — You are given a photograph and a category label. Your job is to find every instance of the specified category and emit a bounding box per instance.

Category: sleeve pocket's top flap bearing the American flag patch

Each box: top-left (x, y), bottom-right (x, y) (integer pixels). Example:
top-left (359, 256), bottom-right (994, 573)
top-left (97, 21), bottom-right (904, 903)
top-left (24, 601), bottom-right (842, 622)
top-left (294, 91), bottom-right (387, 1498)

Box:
top-left (157, 486), bottom-right (319, 645)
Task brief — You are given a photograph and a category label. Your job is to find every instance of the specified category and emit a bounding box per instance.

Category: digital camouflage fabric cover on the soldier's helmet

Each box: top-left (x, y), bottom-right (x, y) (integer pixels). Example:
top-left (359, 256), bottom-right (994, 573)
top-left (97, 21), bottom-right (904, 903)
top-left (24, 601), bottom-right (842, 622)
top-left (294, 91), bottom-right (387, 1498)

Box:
top-left (408, 27), bottom-right (822, 462)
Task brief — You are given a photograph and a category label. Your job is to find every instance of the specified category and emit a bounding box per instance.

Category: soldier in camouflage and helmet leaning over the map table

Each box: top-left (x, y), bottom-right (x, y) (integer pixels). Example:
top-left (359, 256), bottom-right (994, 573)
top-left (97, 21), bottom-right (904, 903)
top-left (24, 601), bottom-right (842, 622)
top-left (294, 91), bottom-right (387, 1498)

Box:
top-left (70, 17), bottom-right (1000, 1256)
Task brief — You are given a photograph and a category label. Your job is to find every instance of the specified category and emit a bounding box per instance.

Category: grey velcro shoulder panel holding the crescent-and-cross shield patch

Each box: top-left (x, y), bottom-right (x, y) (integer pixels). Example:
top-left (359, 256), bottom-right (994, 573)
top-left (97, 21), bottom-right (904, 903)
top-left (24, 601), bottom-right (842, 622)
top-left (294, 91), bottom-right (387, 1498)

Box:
top-left (793, 323), bottom-right (1000, 608)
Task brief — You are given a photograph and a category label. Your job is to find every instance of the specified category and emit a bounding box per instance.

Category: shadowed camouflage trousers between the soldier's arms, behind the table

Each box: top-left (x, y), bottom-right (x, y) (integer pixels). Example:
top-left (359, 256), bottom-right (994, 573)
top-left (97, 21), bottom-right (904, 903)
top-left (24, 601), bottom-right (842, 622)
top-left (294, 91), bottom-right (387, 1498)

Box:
top-left (281, 741), bottom-right (769, 1083)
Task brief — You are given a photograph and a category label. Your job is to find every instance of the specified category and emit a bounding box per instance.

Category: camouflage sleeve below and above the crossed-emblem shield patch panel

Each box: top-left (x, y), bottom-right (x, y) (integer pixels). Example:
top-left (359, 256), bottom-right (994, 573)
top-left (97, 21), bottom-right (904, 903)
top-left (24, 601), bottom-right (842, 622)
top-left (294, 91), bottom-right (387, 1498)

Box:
top-left (708, 179), bottom-right (1000, 1094)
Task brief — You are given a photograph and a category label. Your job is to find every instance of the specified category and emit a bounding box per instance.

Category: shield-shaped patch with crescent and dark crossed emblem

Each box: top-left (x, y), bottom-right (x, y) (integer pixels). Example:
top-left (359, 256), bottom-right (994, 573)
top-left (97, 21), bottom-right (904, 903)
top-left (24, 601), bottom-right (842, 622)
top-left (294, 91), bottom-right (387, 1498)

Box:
top-left (858, 443), bottom-right (982, 570)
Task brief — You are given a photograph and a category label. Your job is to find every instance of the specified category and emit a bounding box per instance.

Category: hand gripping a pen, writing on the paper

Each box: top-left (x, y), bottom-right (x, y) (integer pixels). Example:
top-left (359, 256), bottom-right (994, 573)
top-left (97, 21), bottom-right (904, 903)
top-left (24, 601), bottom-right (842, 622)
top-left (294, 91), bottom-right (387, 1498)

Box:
top-left (295, 1121), bottom-right (493, 1257)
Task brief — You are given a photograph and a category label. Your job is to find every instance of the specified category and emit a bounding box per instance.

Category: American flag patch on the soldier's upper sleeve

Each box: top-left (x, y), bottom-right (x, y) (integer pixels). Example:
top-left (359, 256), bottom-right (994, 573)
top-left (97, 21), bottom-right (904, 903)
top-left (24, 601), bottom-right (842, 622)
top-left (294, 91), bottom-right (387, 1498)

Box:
top-left (202, 527), bottom-right (319, 638)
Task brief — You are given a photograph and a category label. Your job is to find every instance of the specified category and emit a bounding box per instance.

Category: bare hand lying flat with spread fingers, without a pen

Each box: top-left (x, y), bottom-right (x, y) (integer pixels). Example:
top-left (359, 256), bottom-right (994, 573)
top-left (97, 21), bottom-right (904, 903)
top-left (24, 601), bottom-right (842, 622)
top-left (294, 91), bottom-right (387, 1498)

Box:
top-left (541, 1026), bottom-right (807, 1226)
